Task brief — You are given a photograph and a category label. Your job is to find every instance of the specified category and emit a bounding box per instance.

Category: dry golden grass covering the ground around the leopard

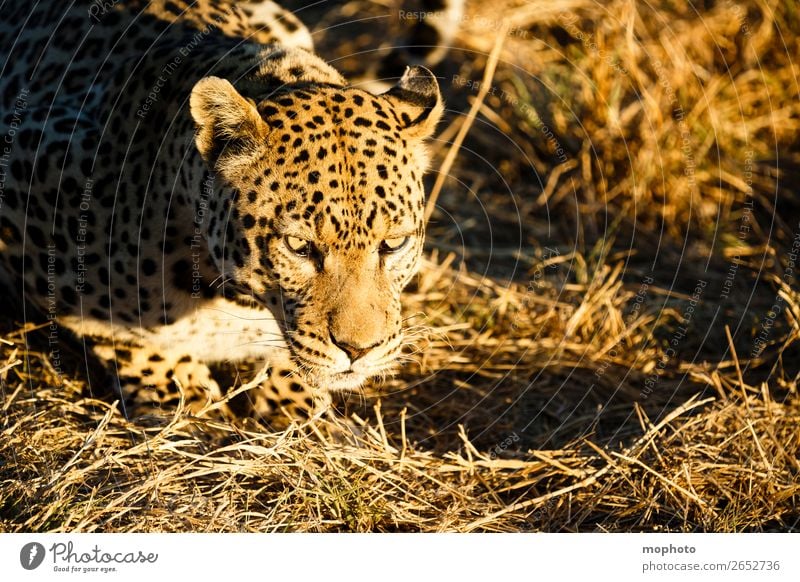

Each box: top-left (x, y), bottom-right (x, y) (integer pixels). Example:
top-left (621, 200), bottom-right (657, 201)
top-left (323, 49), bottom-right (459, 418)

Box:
top-left (0, 0), bottom-right (800, 531)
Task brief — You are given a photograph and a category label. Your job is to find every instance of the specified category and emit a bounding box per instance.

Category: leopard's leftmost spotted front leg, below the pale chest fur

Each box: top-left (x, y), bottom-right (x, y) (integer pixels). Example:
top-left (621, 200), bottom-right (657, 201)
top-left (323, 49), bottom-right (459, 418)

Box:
top-left (94, 344), bottom-right (222, 418)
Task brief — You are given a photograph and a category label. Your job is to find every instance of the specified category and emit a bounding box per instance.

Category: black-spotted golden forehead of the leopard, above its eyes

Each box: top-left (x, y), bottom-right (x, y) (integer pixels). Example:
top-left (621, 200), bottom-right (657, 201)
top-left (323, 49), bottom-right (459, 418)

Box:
top-left (231, 89), bottom-right (427, 249)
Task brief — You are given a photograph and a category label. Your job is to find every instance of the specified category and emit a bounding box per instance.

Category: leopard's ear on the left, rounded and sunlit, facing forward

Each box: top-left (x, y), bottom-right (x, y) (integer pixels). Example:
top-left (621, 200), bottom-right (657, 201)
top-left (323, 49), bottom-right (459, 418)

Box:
top-left (189, 77), bottom-right (267, 167)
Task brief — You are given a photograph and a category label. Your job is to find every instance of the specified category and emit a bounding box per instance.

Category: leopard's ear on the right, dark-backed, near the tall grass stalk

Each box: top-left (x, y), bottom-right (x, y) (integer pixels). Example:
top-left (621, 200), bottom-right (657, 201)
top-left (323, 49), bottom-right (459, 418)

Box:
top-left (383, 66), bottom-right (444, 139)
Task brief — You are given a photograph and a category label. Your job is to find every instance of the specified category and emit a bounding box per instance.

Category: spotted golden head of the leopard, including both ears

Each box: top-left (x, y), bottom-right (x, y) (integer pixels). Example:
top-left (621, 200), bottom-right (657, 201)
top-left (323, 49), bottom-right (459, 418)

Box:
top-left (191, 67), bottom-right (442, 390)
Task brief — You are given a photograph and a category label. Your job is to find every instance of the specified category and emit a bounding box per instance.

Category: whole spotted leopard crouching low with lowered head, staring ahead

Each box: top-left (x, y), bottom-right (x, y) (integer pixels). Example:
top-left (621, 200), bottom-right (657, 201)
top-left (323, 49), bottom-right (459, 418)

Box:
top-left (0, 0), bottom-right (456, 426)
